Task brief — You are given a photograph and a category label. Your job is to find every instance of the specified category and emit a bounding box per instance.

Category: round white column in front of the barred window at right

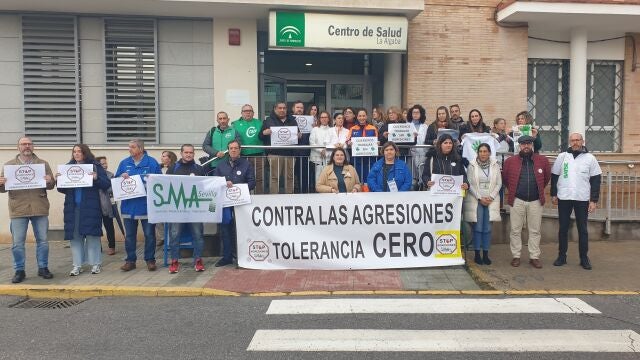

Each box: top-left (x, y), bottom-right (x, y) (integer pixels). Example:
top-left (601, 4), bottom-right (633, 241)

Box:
top-left (569, 28), bottom-right (587, 136)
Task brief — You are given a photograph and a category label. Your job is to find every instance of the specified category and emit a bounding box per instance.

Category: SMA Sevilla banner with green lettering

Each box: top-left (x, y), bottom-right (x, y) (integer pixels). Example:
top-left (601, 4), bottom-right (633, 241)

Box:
top-left (147, 175), bottom-right (227, 224)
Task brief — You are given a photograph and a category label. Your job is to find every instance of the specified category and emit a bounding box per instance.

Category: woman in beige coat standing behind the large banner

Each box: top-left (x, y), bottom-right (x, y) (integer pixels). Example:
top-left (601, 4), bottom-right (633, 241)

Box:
top-left (316, 148), bottom-right (361, 193)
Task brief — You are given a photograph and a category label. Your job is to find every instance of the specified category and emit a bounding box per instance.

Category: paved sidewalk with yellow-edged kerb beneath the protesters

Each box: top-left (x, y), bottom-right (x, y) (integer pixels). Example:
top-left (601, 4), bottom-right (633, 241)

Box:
top-left (0, 241), bottom-right (640, 297)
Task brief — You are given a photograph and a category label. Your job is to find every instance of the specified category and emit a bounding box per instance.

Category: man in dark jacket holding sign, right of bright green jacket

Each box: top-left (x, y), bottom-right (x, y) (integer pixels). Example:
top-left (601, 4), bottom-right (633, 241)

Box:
top-left (260, 101), bottom-right (302, 194)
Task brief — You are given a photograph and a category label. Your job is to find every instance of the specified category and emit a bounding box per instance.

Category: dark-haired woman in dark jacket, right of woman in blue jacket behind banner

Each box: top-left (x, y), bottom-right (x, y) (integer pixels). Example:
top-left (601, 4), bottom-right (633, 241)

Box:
top-left (422, 134), bottom-right (469, 190)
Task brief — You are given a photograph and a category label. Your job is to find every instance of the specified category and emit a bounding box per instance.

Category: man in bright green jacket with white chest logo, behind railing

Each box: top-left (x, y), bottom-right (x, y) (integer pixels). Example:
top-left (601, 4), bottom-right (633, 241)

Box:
top-left (231, 104), bottom-right (265, 194)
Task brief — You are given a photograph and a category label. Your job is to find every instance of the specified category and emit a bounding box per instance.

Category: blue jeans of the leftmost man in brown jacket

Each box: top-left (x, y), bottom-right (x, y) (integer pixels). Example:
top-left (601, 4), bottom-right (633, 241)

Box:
top-left (10, 216), bottom-right (49, 271)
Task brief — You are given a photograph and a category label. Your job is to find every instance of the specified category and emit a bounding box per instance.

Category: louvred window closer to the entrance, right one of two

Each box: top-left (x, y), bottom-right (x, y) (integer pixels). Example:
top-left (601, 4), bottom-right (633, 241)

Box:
top-left (104, 18), bottom-right (158, 142)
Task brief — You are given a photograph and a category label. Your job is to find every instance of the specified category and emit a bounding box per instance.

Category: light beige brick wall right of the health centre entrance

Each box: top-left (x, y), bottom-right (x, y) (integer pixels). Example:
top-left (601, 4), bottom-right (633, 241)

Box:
top-left (405, 0), bottom-right (527, 124)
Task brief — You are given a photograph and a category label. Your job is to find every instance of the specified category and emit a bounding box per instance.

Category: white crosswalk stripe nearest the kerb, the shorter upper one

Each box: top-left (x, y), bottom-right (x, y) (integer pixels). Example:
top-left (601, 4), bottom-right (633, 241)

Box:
top-left (267, 298), bottom-right (600, 315)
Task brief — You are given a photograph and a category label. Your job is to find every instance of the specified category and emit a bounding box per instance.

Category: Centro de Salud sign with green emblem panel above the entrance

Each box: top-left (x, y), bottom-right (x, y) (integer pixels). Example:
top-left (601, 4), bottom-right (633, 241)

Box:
top-left (269, 11), bottom-right (408, 52)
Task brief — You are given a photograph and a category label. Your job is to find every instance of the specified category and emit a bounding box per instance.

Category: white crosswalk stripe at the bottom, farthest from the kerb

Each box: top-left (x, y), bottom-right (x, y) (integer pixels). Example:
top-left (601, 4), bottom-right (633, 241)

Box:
top-left (247, 329), bottom-right (640, 352)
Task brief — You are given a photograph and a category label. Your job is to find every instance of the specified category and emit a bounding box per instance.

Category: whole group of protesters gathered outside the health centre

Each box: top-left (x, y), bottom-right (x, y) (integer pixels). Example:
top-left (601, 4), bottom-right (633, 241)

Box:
top-left (0, 102), bottom-right (601, 283)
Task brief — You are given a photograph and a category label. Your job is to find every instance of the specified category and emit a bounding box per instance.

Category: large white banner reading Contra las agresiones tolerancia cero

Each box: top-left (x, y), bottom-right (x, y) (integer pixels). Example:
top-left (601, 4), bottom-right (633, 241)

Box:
top-left (235, 192), bottom-right (464, 270)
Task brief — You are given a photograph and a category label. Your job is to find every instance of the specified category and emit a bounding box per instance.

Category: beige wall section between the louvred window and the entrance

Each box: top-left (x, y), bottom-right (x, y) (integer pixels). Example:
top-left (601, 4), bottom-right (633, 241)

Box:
top-left (213, 18), bottom-right (259, 124)
